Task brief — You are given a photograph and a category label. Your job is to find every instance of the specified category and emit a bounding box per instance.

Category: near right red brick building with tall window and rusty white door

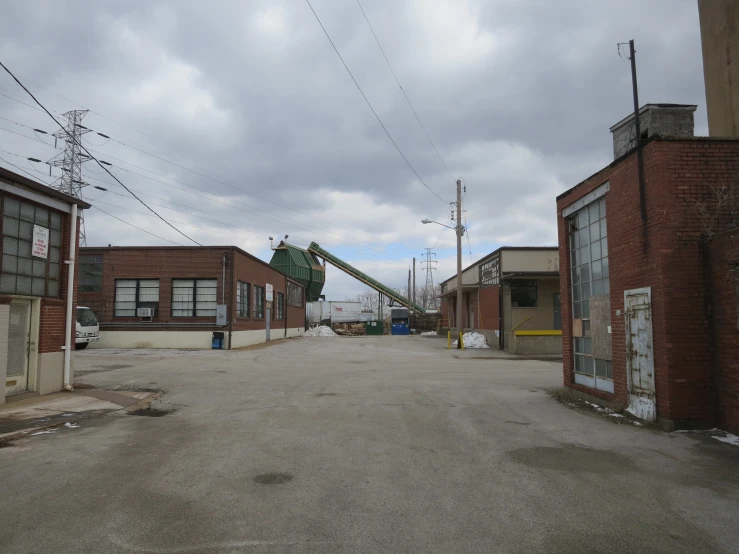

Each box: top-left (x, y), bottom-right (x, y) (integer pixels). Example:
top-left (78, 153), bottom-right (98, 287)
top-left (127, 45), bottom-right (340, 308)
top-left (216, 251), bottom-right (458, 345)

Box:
top-left (557, 105), bottom-right (739, 430)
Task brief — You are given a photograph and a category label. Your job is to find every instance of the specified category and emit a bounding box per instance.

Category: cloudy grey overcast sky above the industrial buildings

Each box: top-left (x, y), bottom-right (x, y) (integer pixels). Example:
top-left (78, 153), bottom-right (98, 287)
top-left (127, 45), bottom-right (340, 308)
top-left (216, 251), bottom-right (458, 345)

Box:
top-left (0, 0), bottom-right (707, 300)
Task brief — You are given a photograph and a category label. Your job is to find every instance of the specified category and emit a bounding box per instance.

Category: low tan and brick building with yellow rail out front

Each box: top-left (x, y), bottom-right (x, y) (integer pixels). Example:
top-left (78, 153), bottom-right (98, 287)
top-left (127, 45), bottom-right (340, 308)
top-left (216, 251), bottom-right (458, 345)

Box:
top-left (441, 246), bottom-right (562, 354)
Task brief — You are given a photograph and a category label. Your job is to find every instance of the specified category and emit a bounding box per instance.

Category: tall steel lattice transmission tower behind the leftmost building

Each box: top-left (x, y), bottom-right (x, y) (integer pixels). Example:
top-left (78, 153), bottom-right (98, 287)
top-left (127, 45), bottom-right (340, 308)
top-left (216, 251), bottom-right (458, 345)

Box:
top-left (49, 110), bottom-right (90, 246)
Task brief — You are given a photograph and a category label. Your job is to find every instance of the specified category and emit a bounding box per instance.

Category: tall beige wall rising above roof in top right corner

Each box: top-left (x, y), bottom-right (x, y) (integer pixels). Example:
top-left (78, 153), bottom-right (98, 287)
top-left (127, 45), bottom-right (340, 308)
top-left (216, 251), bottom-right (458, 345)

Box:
top-left (698, 0), bottom-right (739, 137)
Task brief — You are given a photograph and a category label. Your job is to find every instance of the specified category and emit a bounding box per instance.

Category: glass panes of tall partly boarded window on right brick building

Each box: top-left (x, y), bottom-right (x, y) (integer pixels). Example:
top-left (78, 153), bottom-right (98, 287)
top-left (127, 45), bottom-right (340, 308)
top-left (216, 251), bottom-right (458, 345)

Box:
top-left (568, 197), bottom-right (613, 382)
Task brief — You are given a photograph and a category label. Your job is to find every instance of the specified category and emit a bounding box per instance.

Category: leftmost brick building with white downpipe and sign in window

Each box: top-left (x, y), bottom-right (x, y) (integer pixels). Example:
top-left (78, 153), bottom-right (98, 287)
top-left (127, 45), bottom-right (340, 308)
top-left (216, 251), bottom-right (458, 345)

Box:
top-left (0, 168), bottom-right (90, 404)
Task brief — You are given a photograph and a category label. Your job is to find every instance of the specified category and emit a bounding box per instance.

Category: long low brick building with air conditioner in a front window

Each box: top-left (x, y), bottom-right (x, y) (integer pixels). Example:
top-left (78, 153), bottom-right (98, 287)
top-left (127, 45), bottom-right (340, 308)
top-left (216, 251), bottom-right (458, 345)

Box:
top-left (79, 246), bottom-right (305, 349)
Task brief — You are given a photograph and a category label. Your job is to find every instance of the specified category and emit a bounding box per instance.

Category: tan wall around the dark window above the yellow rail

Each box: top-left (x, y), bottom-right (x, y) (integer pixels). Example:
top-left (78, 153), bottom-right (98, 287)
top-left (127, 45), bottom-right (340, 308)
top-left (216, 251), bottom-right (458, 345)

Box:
top-left (503, 277), bottom-right (559, 350)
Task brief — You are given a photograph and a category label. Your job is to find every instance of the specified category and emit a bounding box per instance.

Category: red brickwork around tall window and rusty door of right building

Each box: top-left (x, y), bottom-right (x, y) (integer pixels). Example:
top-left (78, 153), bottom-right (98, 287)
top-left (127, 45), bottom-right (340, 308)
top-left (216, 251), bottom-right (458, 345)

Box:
top-left (557, 139), bottom-right (739, 420)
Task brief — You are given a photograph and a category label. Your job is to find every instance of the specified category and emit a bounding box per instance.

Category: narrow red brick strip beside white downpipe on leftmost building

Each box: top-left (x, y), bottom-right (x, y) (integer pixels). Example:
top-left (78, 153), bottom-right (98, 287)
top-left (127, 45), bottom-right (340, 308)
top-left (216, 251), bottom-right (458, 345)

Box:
top-left (38, 209), bottom-right (80, 354)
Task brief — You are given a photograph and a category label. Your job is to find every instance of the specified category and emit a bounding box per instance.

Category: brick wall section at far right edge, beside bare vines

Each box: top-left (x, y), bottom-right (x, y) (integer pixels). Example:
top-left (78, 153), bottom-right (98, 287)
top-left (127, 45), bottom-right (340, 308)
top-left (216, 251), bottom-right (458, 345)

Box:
top-left (708, 230), bottom-right (739, 433)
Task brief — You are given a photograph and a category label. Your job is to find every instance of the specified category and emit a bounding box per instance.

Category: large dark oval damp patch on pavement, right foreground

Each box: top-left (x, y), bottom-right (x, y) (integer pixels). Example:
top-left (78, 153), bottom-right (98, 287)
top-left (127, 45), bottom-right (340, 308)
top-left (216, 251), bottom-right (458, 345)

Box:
top-left (508, 444), bottom-right (636, 474)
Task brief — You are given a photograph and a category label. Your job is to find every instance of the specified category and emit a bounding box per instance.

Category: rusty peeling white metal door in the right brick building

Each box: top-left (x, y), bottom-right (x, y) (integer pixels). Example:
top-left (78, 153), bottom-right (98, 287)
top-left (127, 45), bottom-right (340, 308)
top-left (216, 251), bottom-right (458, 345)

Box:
top-left (624, 287), bottom-right (657, 421)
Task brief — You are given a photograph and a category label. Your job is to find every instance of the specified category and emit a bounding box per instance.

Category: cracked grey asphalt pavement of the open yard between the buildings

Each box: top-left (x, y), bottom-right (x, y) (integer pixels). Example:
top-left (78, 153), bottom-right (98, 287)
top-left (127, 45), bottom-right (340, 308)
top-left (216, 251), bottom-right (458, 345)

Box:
top-left (0, 337), bottom-right (739, 554)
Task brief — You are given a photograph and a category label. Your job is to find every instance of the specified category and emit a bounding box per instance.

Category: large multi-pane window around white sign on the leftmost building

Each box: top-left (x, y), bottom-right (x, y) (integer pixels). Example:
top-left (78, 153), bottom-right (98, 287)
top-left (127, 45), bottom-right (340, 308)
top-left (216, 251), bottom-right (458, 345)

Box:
top-left (0, 197), bottom-right (62, 298)
